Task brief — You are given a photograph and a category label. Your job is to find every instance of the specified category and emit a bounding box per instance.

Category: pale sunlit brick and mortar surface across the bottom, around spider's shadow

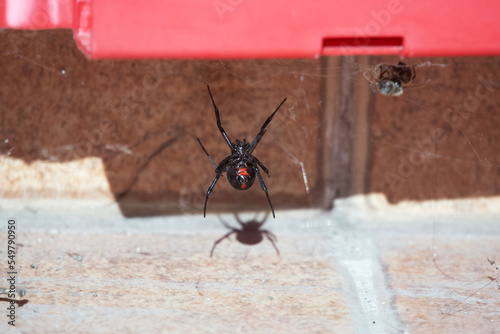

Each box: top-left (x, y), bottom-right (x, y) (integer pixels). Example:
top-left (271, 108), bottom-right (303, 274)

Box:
top-left (0, 197), bottom-right (500, 333)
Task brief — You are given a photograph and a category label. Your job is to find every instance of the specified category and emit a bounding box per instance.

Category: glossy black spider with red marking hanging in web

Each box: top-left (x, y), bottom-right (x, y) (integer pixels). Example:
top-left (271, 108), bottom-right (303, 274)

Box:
top-left (196, 85), bottom-right (286, 218)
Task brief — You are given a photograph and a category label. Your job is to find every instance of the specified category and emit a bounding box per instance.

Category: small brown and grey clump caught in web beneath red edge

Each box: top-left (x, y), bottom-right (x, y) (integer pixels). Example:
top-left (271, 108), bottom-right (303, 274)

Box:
top-left (363, 62), bottom-right (416, 96)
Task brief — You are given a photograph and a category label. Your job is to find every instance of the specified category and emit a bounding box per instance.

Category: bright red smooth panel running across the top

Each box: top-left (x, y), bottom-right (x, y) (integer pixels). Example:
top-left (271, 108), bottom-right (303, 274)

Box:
top-left (0, 0), bottom-right (500, 58)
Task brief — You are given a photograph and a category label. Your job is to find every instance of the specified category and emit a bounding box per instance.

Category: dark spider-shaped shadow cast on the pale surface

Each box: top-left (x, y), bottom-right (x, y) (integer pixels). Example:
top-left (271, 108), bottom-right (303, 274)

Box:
top-left (210, 213), bottom-right (280, 257)
